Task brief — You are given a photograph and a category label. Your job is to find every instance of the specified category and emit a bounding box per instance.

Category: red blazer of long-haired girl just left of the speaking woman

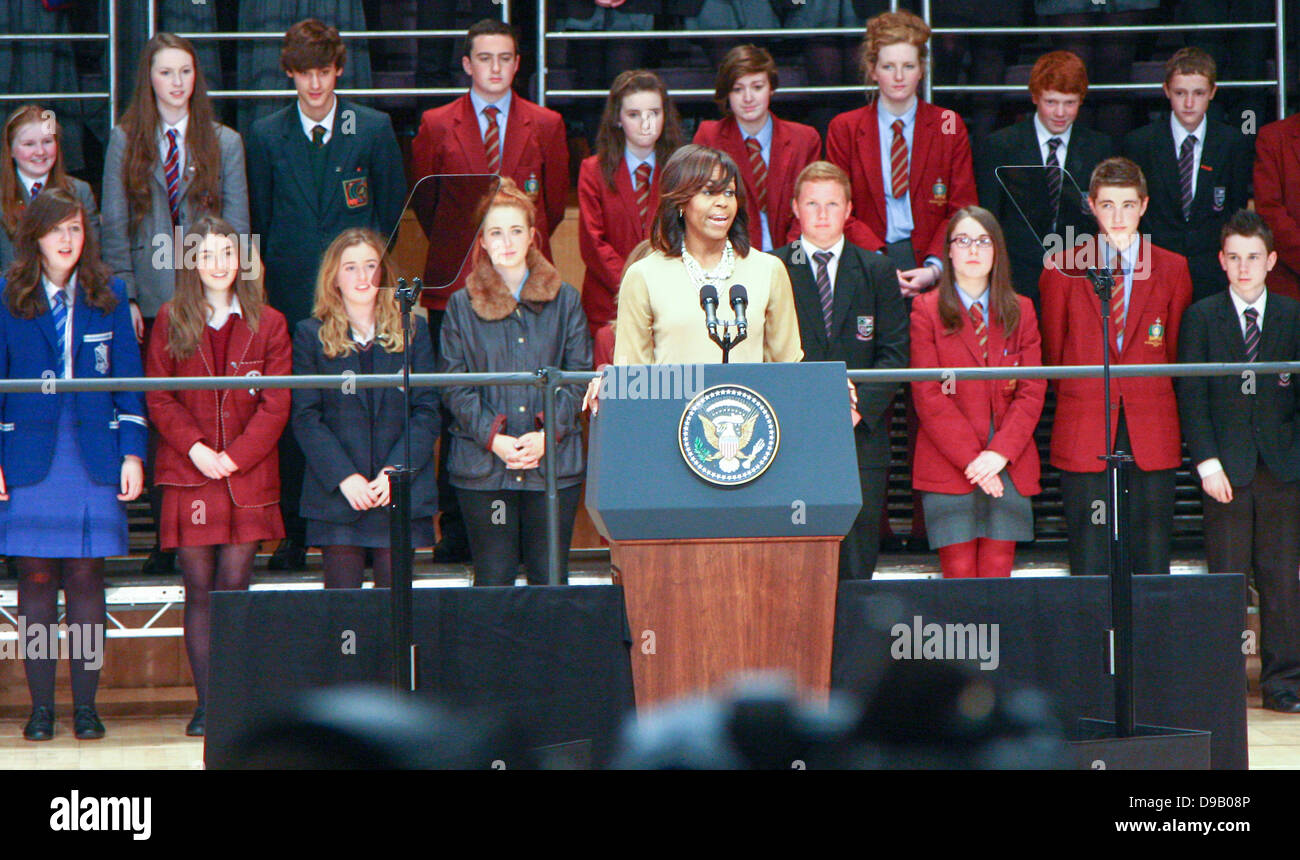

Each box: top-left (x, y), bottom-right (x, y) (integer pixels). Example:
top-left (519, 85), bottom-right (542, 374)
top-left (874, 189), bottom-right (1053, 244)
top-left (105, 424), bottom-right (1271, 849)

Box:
top-left (577, 156), bottom-right (663, 334)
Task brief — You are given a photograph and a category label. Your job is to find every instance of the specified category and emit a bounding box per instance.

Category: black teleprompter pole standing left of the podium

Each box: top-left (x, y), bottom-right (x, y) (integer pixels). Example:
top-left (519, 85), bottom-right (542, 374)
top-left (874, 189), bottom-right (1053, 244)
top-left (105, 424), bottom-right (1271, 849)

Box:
top-left (389, 278), bottom-right (424, 694)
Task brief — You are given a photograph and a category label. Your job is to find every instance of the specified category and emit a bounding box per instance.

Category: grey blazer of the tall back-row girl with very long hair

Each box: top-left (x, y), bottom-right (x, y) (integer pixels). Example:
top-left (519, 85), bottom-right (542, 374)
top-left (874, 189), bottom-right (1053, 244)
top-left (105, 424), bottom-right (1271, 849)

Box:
top-left (103, 123), bottom-right (248, 318)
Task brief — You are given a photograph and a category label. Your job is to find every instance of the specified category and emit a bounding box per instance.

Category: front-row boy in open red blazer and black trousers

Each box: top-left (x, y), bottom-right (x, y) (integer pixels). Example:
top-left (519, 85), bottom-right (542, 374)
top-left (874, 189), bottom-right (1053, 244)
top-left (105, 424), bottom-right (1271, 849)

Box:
top-left (1039, 158), bottom-right (1192, 575)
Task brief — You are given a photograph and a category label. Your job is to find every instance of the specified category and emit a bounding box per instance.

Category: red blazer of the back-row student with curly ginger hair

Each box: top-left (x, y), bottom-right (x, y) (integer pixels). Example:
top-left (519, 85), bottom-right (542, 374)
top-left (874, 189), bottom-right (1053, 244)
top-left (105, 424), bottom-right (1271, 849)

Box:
top-left (826, 99), bottom-right (976, 266)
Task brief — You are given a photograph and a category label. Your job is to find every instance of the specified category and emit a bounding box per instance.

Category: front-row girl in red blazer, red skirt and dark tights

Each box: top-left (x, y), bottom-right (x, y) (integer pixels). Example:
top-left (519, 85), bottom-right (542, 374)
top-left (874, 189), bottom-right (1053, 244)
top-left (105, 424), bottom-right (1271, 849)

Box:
top-left (147, 216), bottom-right (293, 737)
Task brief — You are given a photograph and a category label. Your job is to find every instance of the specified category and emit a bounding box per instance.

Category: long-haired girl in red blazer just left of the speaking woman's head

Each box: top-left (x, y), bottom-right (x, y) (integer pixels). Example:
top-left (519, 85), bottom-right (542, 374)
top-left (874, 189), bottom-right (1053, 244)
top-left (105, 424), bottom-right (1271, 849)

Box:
top-left (577, 69), bottom-right (681, 338)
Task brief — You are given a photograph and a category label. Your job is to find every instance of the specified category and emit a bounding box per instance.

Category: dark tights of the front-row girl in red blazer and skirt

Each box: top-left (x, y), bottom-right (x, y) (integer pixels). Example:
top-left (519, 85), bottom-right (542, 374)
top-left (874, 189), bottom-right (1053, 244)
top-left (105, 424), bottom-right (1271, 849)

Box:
top-left (176, 540), bottom-right (257, 707)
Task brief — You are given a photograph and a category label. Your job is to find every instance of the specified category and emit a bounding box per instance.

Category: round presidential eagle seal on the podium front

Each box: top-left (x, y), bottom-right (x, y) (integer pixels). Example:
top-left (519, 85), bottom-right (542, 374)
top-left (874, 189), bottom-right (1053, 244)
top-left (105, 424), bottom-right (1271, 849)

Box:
top-left (677, 385), bottom-right (781, 487)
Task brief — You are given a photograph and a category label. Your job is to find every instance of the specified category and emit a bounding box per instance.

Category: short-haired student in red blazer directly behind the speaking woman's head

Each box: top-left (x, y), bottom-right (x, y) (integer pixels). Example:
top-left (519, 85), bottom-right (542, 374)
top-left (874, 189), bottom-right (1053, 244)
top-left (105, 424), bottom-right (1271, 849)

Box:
top-left (693, 44), bottom-right (822, 251)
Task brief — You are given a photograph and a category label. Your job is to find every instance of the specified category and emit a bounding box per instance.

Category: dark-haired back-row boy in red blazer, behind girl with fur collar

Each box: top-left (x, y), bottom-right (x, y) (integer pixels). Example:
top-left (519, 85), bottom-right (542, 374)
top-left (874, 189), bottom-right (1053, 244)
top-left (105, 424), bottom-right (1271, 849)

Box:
top-left (411, 18), bottom-right (568, 329)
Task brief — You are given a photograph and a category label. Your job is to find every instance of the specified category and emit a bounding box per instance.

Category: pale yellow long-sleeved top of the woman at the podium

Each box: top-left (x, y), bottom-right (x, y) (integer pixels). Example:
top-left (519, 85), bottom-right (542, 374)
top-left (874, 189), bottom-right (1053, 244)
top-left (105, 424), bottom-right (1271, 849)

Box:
top-left (614, 249), bottom-right (803, 364)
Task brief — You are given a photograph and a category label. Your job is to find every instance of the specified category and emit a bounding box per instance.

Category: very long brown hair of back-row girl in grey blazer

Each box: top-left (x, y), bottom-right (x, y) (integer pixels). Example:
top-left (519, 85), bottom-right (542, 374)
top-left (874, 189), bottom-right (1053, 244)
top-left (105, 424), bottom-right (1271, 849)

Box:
top-left (121, 32), bottom-right (221, 231)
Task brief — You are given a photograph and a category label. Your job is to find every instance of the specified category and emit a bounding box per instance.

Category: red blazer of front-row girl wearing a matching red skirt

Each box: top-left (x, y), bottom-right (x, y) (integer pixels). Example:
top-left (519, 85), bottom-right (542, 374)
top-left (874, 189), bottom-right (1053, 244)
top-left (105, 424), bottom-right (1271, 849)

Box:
top-left (146, 303), bottom-right (294, 508)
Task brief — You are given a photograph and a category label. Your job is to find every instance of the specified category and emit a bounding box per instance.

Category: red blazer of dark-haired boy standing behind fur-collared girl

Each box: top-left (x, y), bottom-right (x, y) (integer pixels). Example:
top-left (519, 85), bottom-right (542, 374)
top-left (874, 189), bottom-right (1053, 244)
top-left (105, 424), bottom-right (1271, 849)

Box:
top-left (411, 92), bottom-right (568, 310)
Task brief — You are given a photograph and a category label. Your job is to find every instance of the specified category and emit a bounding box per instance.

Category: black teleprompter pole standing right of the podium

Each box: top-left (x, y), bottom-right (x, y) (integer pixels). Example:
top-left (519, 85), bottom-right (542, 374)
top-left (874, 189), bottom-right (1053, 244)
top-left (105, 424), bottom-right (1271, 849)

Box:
top-left (1087, 265), bottom-right (1135, 738)
